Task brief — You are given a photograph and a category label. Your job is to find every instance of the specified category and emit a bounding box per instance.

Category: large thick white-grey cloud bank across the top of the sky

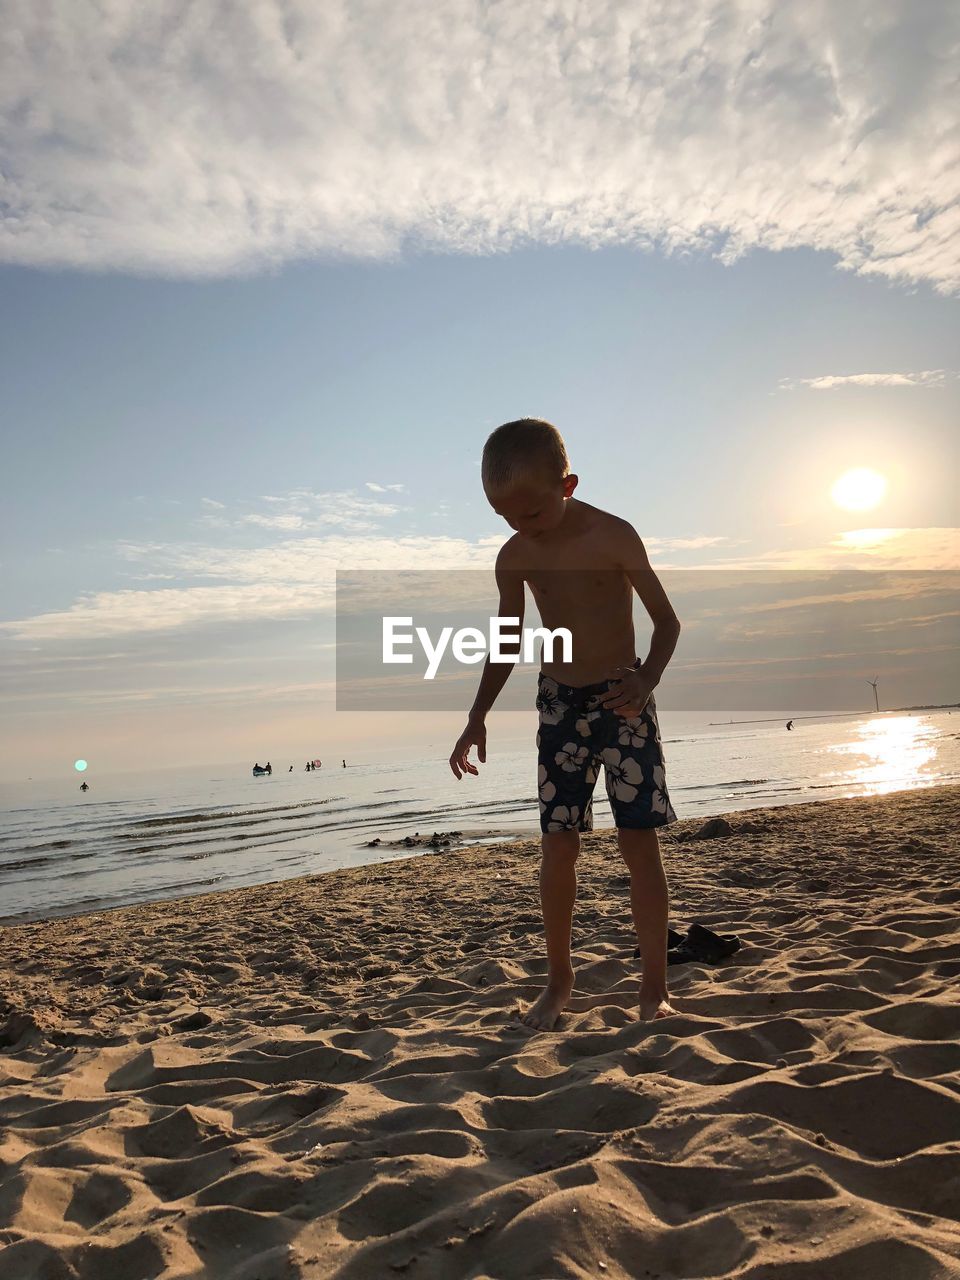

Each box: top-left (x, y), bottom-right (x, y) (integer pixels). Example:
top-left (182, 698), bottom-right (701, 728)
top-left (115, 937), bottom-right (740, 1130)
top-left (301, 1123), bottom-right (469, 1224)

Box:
top-left (0, 0), bottom-right (960, 292)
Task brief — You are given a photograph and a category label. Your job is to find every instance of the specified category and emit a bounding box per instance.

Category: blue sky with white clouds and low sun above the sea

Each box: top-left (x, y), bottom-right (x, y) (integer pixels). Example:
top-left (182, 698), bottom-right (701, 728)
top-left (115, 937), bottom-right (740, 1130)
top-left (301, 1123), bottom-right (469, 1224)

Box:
top-left (0, 0), bottom-right (960, 777)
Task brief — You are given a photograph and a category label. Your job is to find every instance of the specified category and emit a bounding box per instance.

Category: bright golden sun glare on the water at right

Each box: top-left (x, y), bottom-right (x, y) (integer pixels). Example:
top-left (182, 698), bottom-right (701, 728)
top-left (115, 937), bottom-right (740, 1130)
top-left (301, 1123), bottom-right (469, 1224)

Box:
top-left (827, 716), bottom-right (941, 796)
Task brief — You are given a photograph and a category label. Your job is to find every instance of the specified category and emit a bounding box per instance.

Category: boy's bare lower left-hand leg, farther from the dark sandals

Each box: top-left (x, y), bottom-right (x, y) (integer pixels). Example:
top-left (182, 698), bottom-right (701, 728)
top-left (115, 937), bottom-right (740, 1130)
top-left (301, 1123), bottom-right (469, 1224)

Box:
top-left (521, 831), bottom-right (580, 1030)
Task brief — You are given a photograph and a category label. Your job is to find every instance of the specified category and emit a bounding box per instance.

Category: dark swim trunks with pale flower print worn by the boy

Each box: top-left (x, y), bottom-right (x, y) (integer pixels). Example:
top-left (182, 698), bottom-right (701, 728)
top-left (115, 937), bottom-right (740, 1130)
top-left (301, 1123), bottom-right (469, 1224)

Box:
top-left (536, 672), bottom-right (677, 832)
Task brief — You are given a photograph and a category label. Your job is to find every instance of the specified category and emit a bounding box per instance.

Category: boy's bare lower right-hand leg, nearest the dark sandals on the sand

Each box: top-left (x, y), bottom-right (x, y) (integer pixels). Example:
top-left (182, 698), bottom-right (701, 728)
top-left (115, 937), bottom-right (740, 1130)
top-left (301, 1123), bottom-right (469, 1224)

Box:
top-left (617, 827), bottom-right (676, 1021)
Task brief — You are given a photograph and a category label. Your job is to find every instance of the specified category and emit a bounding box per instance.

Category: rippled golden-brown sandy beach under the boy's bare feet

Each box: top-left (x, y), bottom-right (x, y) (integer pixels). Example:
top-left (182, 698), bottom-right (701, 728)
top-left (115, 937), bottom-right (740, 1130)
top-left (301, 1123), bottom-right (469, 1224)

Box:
top-left (0, 786), bottom-right (960, 1280)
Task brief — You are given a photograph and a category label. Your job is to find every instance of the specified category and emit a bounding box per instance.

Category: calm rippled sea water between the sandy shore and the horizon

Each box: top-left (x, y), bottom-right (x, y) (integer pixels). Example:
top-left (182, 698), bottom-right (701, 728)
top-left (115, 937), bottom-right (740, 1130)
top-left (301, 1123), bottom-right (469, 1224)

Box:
top-left (0, 709), bottom-right (960, 923)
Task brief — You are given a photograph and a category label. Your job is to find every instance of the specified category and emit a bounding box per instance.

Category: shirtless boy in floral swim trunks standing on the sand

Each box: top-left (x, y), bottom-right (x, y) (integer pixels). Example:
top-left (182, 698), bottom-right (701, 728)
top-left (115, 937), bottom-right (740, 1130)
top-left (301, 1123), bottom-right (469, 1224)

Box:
top-left (449, 419), bottom-right (680, 1030)
